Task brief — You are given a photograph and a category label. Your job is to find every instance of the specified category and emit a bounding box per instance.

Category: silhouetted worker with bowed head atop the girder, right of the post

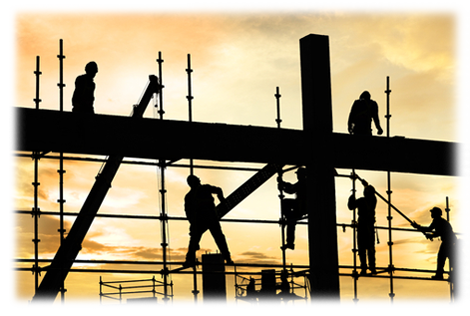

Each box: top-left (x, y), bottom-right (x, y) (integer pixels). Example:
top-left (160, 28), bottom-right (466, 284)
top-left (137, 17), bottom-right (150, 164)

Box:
top-left (348, 91), bottom-right (383, 135)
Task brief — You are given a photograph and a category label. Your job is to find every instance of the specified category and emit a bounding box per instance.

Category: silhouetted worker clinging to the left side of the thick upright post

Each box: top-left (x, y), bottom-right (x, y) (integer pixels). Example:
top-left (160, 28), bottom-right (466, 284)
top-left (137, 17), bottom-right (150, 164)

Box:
top-left (277, 167), bottom-right (307, 249)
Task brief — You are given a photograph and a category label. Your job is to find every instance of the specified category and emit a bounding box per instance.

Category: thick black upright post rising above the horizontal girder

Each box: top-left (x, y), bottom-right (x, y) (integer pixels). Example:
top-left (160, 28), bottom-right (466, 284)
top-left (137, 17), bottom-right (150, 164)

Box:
top-left (300, 34), bottom-right (340, 308)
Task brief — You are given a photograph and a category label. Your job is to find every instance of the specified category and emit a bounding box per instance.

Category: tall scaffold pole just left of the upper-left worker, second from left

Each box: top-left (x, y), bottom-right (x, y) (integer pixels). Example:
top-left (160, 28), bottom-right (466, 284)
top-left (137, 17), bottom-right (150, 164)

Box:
top-left (57, 39), bottom-right (67, 309)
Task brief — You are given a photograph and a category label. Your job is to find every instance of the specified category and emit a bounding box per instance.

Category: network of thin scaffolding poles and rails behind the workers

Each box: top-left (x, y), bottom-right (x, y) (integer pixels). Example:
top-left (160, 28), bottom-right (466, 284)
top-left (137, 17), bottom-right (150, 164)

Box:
top-left (8, 40), bottom-right (470, 309)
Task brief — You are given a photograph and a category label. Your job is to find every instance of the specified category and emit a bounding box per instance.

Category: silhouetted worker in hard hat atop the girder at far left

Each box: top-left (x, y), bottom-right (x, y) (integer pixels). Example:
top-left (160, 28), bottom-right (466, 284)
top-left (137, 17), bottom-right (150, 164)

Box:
top-left (72, 61), bottom-right (98, 114)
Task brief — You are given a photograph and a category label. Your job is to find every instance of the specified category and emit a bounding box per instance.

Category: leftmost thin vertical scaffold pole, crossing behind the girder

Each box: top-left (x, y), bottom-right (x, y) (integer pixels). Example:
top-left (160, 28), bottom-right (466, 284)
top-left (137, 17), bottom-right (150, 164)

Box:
top-left (31, 56), bottom-right (42, 293)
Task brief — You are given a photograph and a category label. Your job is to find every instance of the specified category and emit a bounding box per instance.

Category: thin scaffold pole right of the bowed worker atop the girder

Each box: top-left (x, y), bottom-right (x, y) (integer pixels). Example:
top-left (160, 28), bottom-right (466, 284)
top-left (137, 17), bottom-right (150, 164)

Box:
top-left (385, 76), bottom-right (395, 309)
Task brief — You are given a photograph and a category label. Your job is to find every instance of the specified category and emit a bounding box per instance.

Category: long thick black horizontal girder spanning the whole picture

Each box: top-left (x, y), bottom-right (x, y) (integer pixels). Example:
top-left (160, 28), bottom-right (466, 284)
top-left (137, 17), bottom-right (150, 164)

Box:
top-left (8, 107), bottom-right (470, 177)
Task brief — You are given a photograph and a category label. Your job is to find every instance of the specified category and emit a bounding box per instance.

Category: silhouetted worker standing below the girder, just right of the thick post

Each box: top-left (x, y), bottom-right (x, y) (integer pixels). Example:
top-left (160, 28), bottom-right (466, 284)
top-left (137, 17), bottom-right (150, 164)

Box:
top-left (348, 180), bottom-right (377, 275)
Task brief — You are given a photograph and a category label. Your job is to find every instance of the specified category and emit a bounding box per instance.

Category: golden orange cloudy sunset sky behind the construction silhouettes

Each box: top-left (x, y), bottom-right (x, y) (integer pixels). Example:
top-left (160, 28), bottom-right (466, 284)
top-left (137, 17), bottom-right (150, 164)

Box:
top-left (6, 1), bottom-right (470, 309)
